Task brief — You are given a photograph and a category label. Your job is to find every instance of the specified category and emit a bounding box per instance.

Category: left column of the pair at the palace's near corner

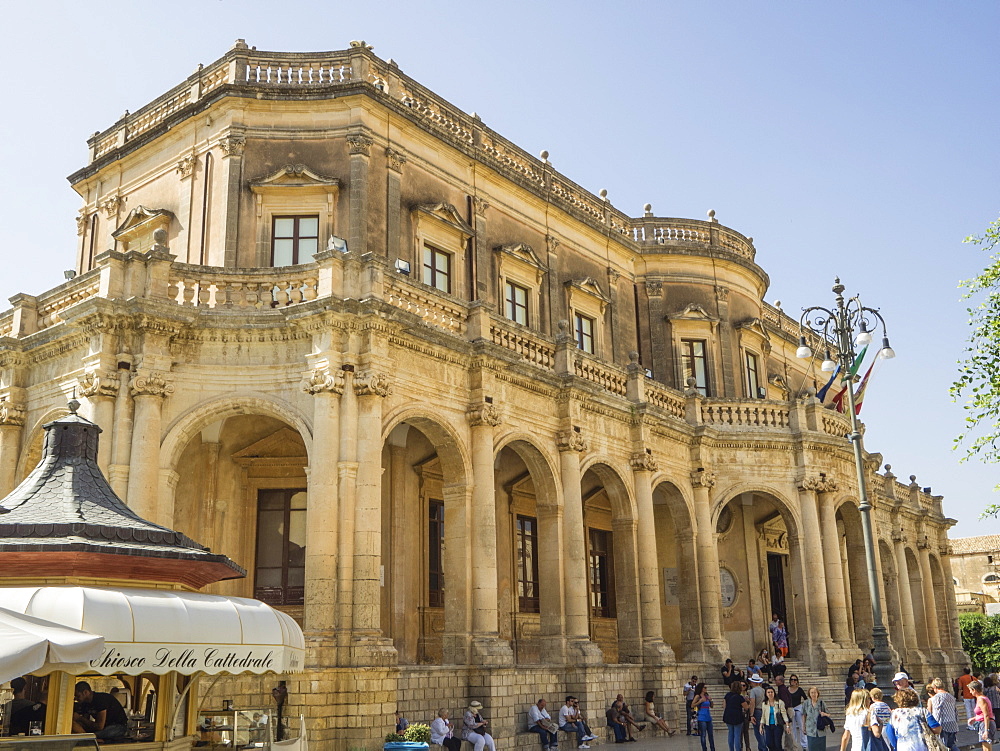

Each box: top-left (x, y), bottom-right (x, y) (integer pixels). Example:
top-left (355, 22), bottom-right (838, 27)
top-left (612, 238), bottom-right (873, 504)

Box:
top-left (302, 368), bottom-right (344, 633)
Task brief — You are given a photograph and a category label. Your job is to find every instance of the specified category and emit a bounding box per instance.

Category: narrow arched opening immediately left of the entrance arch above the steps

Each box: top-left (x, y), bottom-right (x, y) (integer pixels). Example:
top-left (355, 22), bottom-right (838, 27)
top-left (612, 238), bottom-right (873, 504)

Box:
top-left (653, 482), bottom-right (703, 662)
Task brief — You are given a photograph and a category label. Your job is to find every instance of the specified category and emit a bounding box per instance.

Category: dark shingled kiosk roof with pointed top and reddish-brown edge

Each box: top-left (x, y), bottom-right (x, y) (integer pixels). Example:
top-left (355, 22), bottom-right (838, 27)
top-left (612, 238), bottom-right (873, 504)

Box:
top-left (0, 400), bottom-right (246, 587)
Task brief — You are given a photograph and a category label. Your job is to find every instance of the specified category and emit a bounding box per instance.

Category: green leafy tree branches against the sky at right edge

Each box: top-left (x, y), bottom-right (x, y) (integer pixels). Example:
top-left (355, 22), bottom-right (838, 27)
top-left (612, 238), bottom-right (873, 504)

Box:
top-left (951, 214), bottom-right (1000, 516)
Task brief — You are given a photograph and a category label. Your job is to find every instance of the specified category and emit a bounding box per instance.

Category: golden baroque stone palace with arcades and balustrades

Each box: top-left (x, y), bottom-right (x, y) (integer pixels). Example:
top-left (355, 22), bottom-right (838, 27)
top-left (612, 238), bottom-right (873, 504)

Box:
top-left (0, 41), bottom-right (965, 749)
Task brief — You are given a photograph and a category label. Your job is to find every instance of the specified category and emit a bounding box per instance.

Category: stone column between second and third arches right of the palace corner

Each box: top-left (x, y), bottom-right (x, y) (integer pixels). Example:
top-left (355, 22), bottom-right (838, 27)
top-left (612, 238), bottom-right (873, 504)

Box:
top-left (556, 430), bottom-right (603, 662)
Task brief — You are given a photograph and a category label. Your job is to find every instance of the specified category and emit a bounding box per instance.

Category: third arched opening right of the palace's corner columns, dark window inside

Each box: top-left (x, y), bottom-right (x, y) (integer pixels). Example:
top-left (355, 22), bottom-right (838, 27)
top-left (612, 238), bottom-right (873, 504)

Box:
top-left (581, 461), bottom-right (642, 663)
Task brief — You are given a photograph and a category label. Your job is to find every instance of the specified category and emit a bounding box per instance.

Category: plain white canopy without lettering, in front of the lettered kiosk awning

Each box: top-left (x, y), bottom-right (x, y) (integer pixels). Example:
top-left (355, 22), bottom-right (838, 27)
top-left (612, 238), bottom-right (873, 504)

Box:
top-left (0, 608), bottom-right (104, 683)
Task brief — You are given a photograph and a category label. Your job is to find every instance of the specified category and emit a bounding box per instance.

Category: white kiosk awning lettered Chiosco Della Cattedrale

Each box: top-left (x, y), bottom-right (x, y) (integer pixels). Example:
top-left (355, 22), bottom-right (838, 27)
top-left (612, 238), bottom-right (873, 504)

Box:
top-left (0, 587), bottom-right (305, 675)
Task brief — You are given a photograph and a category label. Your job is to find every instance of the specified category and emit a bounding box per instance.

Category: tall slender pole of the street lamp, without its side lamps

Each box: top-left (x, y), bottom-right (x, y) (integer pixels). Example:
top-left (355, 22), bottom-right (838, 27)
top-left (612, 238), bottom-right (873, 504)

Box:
top-left (833, 279), bottom-right (895, 690)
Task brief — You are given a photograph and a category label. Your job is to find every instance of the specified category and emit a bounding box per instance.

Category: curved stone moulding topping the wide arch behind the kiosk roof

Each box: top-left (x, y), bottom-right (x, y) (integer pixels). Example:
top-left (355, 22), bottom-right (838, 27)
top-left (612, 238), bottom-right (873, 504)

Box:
top-left (160, 393), bottom-right (312, 469)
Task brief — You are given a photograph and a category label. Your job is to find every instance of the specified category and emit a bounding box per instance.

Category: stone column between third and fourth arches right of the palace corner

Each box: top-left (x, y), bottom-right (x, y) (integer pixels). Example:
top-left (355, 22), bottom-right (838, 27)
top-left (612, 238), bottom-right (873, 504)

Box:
top-left (630, 451), bottom-right (666, 657)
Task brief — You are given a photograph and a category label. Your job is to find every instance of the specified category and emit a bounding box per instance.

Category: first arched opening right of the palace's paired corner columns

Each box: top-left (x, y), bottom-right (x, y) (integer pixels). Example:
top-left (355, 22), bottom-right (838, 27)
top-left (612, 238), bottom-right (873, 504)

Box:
top-left (380, 415), bottom-right (474, 665)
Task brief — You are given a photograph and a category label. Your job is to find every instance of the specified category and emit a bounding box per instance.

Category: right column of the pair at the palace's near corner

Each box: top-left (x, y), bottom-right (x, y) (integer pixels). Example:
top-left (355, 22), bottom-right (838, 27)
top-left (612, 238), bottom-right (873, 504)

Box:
top-left (352, 371), bottom-right (392, 656)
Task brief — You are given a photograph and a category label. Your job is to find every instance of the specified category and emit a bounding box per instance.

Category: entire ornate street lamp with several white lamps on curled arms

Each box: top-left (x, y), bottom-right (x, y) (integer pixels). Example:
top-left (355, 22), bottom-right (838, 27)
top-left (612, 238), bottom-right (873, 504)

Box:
top-left (795, 278), bottom-right (896, 689)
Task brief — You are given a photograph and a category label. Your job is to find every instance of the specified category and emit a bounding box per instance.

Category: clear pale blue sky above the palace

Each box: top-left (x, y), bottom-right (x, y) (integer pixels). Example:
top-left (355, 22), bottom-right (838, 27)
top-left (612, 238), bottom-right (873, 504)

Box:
top-left (0, 0), bottom-right (1000, 536)
